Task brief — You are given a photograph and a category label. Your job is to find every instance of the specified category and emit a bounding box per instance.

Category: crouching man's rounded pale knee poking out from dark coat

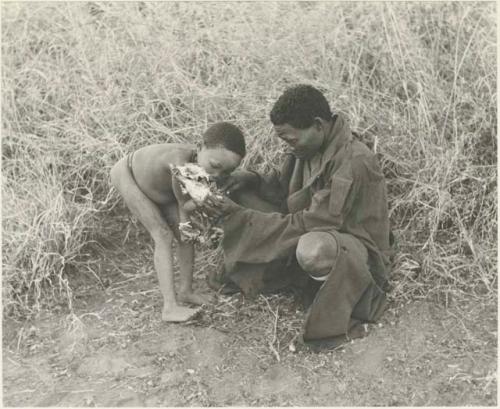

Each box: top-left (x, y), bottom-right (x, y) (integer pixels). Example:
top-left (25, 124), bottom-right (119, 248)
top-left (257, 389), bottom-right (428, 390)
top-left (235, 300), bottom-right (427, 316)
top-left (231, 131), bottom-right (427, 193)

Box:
top-left (296, 232), bottom-right (338, 278)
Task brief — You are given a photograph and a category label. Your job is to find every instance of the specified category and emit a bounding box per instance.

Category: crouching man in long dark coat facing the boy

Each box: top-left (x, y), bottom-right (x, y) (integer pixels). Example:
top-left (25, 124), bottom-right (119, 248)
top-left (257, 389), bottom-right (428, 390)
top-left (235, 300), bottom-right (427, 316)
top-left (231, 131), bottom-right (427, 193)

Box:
top-left (204, 85), bottom-right (391, 344)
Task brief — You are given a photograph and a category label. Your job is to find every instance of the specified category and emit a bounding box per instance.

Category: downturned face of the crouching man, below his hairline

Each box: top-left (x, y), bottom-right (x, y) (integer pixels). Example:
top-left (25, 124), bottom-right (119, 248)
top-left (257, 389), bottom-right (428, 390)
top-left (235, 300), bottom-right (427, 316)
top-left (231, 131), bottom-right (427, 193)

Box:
top-left (274, 121), bottom-right (325, 159)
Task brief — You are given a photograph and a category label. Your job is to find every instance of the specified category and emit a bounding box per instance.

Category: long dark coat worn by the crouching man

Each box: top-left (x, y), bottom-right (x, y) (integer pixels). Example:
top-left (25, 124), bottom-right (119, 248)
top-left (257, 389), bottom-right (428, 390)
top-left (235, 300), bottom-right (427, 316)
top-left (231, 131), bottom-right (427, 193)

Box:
top-left (223, 114), bottom-right (391, 339)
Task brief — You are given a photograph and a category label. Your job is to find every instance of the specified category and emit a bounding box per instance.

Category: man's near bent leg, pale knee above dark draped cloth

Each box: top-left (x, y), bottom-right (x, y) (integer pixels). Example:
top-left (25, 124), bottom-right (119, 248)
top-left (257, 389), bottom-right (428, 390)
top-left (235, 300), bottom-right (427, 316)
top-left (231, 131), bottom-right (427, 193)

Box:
top-left (296, 231), bottom-right (385, 341)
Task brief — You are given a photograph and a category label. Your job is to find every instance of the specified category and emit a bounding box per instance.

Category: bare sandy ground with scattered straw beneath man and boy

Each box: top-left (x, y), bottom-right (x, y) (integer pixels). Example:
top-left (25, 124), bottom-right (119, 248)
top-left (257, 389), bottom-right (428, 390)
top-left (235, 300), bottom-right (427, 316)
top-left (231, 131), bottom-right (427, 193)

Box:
top-left (3, 245), bottom-right (497, 407)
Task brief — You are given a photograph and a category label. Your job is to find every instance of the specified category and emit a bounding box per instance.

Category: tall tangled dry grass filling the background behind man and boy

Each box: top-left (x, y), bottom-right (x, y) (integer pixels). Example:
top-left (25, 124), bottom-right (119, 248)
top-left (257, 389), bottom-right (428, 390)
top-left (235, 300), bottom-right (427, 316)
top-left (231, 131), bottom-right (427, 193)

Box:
top-left (1, 2), bottom-right (497, 314)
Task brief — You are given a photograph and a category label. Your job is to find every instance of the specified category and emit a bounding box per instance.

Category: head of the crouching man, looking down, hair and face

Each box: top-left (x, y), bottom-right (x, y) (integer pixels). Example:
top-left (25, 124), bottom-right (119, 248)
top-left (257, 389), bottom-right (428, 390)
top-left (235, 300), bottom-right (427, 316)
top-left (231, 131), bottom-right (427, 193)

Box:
top-left (270, 84), bottom-right (332, 158)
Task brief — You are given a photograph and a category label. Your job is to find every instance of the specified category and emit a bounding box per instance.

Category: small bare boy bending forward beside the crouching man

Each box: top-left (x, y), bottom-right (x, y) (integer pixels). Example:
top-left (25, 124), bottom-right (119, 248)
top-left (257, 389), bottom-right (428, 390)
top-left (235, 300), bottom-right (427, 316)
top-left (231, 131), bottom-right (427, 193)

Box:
top-left (111, 122), bottom-right (245, 322)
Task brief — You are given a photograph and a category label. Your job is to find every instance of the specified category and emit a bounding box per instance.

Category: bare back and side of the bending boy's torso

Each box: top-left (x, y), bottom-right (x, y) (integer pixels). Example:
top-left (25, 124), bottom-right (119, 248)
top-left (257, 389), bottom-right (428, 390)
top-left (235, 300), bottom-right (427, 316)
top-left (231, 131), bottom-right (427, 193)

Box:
top-left (132, 143), bottom-right (196, 206)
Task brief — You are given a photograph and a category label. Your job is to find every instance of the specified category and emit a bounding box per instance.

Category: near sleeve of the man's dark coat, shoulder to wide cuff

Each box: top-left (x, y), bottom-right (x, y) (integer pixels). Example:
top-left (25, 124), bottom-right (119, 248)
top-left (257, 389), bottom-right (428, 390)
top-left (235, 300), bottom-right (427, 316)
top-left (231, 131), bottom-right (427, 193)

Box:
top-left (223, 156), bottom-right (368, 263)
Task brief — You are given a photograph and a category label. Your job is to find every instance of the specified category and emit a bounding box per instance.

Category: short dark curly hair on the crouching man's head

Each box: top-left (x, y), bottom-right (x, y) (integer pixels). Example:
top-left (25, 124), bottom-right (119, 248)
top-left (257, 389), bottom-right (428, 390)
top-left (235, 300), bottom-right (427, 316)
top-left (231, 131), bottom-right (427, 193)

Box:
top-left (269, 84), bottom-right (332, 129)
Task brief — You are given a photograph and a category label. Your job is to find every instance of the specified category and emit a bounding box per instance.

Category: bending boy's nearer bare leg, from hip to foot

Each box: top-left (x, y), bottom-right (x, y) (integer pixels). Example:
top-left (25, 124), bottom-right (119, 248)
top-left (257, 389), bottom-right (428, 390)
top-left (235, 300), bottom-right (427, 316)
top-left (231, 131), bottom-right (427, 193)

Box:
top-left (111, 159), bottom-right (199, 322)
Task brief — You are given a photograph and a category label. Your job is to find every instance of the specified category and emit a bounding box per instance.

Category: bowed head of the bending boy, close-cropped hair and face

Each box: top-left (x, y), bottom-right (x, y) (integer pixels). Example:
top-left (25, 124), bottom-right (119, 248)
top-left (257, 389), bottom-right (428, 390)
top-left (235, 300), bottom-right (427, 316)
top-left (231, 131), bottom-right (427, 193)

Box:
top-left (198, 122), bottom-right (246, 177)
